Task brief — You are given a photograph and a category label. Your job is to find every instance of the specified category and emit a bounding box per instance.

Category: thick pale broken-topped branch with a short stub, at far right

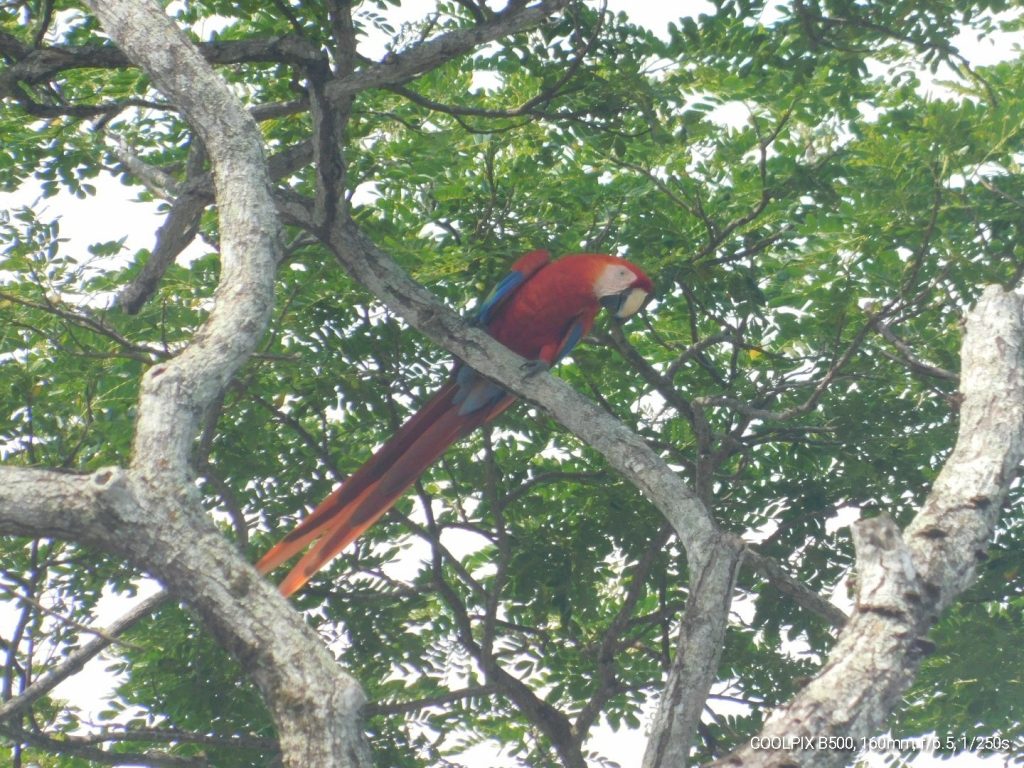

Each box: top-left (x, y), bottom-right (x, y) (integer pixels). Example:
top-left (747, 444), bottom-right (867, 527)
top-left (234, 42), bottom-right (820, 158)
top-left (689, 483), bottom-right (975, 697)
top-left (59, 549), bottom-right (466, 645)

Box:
top-left (716, 286), bottom-right (1024, 766)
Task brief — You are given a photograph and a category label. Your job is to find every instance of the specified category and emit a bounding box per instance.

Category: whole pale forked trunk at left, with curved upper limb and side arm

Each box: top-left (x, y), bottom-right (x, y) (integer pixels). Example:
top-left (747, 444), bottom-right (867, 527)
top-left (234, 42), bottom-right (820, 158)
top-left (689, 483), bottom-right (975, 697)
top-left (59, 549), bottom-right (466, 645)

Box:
top-left (0, 0), bottom-right (371, 767)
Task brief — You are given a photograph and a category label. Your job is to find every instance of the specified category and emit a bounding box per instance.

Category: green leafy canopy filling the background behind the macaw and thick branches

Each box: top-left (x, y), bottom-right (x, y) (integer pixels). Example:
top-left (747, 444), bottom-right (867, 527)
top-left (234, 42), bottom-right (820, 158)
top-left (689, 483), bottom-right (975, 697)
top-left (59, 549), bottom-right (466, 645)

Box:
top-left (0, 0), bottom-right (1024, 768)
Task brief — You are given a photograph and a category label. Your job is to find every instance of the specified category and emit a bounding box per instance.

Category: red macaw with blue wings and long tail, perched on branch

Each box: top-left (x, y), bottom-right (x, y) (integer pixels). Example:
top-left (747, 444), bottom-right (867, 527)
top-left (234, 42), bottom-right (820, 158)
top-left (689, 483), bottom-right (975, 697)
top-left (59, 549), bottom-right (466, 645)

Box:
top-left (256, 251), bottom-right (652, 597)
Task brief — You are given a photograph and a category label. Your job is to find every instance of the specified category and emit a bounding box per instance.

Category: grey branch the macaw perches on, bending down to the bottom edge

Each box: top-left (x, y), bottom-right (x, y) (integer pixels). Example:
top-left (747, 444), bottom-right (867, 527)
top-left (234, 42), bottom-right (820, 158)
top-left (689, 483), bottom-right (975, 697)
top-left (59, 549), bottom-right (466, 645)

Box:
top-left (319, 213), bottom-right (742, 765)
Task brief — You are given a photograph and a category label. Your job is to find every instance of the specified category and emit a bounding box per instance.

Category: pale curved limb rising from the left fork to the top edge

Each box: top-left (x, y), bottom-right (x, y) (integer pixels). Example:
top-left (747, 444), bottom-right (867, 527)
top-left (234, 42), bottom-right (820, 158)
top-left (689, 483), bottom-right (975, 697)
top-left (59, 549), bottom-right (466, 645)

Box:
top-left (82, 0), bottom-right (280, 479)
